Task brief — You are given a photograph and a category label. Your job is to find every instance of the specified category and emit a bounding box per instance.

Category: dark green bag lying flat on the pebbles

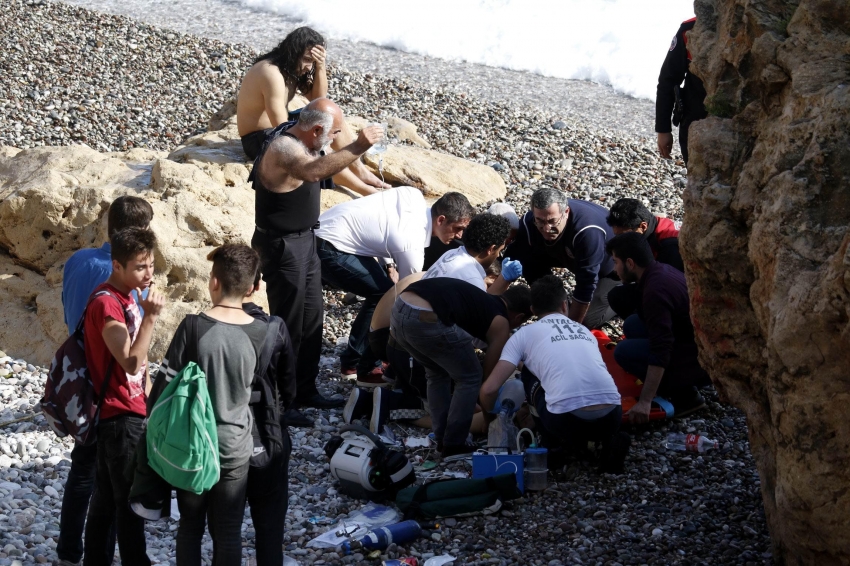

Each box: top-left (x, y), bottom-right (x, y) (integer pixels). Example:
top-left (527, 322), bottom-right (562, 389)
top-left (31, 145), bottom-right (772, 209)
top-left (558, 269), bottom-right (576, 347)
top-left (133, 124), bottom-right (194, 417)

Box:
top-left (395, 474), bottom-right (522, 520)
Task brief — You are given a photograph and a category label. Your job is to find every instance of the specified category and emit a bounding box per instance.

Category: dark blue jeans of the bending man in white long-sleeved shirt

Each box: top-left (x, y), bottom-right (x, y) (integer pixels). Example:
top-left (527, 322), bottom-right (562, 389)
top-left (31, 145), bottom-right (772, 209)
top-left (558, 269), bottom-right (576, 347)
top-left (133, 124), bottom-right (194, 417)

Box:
top-left (316, 238), bottom-right (393, 375)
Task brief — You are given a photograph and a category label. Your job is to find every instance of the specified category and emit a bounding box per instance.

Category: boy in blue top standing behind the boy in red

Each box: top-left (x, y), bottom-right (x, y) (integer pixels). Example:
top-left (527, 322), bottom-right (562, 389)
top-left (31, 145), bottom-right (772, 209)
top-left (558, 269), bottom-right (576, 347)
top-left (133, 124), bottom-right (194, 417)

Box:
top-left (56, 196), bottom-right (153, 565)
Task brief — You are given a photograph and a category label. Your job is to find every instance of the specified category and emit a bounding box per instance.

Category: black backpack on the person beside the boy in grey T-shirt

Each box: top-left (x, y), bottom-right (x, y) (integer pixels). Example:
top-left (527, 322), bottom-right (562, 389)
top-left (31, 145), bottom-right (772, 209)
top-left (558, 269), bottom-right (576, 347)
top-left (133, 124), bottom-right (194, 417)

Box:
top-left (249, 316), bottom-right (283, 468)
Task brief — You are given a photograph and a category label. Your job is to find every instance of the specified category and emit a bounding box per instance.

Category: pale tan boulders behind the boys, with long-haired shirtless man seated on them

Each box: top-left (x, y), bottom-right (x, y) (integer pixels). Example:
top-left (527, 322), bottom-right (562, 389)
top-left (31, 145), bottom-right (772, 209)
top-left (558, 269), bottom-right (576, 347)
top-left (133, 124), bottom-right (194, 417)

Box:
top-left (0, 108), bottom-right (505, 363)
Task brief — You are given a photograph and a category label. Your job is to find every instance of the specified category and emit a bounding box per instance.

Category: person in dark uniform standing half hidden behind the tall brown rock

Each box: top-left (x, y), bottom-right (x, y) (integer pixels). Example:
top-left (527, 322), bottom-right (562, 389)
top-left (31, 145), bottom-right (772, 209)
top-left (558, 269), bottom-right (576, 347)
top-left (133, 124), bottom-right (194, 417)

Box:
top-left (655, 18), bottom-right (707, 164)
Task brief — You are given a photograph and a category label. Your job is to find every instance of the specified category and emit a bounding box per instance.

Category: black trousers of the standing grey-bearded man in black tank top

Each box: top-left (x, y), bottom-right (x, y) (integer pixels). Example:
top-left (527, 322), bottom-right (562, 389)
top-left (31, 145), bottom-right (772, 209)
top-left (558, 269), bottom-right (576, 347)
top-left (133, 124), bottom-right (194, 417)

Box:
top-left (251, 230), bottom-right (324, 400)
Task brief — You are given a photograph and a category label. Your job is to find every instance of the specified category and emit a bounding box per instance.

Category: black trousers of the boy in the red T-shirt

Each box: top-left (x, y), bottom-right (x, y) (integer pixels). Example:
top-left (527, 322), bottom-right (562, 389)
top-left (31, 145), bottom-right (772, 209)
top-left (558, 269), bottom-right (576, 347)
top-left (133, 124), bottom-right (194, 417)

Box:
top-left (83, 415), bottom-right (151, 566)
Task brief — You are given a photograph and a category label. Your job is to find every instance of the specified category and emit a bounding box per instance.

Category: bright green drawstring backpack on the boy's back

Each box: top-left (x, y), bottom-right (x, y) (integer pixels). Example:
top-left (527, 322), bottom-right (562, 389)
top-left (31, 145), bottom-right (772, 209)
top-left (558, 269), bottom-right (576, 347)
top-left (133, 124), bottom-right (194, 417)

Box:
top-left (147, 315), bottom-right (221, 494)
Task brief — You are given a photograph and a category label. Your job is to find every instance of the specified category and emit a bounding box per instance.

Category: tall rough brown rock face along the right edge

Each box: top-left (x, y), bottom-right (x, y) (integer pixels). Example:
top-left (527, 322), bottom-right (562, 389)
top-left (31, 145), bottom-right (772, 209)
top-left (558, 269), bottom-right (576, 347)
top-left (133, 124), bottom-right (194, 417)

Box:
top-left (681, 0), bottom-right (850, 564)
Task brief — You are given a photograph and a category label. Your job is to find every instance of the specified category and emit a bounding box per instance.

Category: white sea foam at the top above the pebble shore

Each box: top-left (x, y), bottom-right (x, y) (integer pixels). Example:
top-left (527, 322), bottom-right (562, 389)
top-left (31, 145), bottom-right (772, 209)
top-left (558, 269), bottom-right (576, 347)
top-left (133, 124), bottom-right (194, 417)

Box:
top-left (239, 0), bottom-right (693, 100)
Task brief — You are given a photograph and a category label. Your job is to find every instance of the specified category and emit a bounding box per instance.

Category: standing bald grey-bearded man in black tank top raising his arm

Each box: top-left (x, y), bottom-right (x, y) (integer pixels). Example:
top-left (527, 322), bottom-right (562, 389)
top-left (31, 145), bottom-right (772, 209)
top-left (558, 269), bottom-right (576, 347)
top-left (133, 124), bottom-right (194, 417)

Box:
top-left (251, 98), bottom-right (383, 426)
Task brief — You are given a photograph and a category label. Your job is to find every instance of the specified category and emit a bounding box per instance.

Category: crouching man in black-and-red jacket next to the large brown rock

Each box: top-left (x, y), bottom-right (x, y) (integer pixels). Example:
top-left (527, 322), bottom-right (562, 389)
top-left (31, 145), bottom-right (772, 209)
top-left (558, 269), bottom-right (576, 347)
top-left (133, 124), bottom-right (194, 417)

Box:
top-left (607, 198), bottom-right (685, 320)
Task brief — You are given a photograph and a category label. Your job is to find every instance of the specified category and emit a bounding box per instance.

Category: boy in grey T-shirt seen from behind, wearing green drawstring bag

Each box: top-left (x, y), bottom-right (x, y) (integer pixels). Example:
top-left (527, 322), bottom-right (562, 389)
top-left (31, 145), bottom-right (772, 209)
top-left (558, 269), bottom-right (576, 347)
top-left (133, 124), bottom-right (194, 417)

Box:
top-left (148, 244), bottom-right (269, 566)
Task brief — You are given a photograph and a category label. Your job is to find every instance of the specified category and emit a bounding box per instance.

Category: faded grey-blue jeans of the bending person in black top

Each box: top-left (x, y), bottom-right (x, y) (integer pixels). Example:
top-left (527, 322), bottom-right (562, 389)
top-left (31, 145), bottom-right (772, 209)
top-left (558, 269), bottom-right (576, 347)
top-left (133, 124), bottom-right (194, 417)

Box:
top-left (391, 299), bottom-right (483, 446)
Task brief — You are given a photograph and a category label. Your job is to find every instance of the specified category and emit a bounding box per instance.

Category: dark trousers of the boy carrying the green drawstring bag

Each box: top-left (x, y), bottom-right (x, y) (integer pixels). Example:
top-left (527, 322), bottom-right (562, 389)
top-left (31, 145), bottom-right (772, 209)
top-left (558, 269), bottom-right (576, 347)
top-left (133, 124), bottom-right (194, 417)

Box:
top-left (177, 462), bottom-right (248, 566)
